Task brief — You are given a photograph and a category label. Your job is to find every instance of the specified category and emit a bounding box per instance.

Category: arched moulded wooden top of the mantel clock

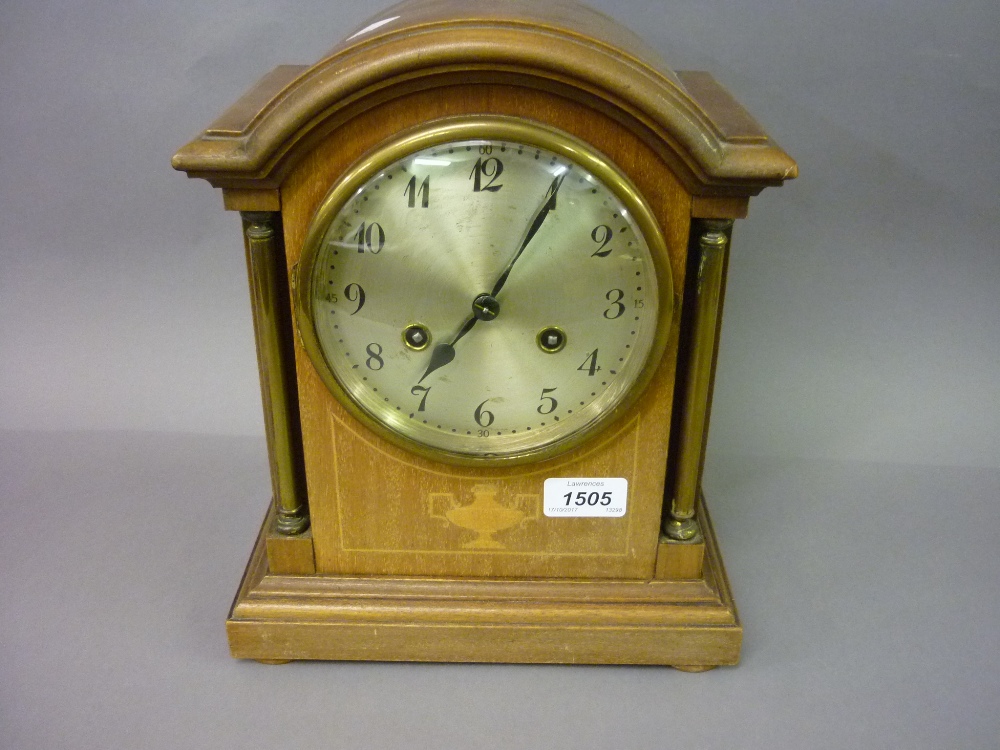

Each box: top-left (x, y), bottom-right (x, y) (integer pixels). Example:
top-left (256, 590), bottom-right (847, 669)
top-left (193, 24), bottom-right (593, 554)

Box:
top-left (173, 0), bottom-right (797, 196)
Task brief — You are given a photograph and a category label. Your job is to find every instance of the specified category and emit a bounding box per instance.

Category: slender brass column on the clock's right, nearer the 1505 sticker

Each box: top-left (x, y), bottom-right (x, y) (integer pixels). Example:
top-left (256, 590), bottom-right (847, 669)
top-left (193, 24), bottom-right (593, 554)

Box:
top-left (663, 219), bottom-right (733, 542)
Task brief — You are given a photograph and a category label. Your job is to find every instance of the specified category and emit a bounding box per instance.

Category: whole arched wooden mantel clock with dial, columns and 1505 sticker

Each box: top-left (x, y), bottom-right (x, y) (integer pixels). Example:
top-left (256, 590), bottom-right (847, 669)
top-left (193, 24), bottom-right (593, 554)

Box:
top-left (174, 0), bottom-right (796, 670)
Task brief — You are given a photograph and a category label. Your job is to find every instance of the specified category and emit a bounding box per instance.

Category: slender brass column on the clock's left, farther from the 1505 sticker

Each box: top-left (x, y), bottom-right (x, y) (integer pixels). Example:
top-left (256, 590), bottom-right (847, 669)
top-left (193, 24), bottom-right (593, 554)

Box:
top-left (241, 211), bottom-right (309, 535)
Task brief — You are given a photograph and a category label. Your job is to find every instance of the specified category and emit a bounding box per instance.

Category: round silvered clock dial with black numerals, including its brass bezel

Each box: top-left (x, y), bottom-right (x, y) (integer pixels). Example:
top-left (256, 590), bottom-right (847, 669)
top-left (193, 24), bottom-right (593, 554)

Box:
top-left (297, 118), bottom-right (672, 462)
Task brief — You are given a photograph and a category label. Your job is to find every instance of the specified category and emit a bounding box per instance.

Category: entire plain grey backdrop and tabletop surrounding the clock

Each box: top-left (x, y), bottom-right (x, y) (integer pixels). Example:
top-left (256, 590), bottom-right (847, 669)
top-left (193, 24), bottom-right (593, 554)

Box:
top-left (0, 0), bottom-right (1000, 748)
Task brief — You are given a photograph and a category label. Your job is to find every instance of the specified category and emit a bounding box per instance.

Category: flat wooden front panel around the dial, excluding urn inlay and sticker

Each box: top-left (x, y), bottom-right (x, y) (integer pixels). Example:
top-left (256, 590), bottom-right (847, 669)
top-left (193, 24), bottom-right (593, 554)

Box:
top-left (281, 84), bottom-right (690, 578)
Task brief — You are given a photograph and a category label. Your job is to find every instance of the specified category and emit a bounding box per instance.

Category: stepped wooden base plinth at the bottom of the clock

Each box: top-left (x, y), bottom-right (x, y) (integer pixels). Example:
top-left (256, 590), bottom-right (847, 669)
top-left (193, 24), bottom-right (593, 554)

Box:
top-left (227, 496), bottom-right (743, 671)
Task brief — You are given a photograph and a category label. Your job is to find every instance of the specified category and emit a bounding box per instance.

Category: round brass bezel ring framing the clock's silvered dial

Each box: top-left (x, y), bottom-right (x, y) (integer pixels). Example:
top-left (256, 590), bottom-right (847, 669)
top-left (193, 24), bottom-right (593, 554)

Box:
top-left (294, 115), bottom-right (674, 466)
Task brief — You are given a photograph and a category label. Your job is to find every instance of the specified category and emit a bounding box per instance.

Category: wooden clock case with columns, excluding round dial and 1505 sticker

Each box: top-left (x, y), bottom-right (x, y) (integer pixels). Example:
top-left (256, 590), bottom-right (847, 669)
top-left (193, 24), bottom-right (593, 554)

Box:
top-left (174, 1), bottom-right (796, 670)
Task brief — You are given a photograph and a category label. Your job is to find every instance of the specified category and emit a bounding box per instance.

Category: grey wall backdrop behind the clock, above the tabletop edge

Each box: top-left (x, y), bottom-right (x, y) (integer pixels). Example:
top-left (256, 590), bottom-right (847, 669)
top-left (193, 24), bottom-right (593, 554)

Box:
top-left (0, 0), bottom-right (1000, 466)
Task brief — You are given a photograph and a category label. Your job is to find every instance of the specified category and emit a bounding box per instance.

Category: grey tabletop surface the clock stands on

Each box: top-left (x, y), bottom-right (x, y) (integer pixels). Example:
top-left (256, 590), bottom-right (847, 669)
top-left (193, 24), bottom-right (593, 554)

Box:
top-left (0, 432), bottom-right (1000, 750)
